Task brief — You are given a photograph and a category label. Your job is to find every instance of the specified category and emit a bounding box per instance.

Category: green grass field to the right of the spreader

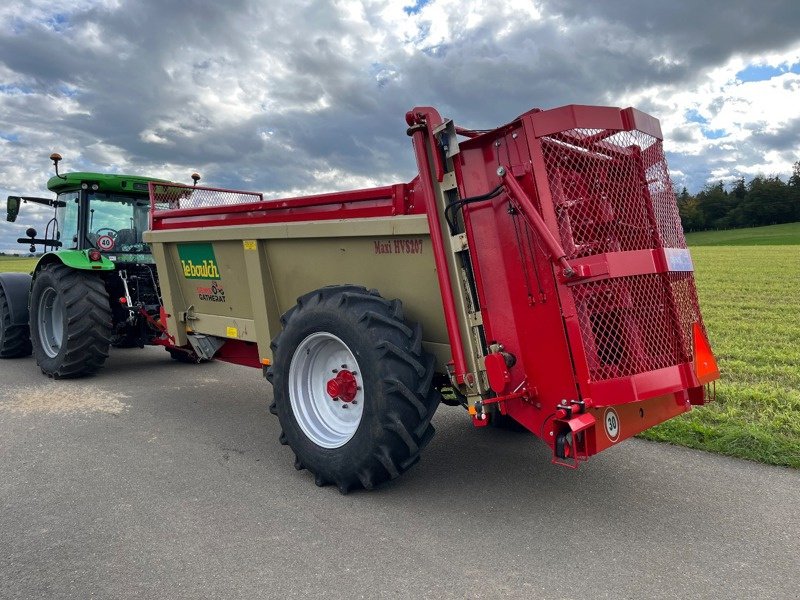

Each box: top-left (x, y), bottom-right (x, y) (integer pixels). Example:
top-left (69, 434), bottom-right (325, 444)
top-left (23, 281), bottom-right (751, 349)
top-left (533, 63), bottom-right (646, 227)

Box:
top-left (642, 238), bottom-right (800, 468)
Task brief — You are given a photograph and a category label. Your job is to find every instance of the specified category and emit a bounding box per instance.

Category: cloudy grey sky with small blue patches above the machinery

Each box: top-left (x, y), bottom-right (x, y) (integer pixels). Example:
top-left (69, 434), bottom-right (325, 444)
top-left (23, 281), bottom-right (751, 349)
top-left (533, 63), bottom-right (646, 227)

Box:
top-left (0, 0), bottom-right (800, 250)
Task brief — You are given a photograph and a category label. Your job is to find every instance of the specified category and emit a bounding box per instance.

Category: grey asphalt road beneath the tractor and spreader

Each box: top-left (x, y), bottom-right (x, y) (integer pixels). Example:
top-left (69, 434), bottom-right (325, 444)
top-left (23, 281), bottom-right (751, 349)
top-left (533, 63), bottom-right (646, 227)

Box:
top-left (0, 348), bottom-right (800, 600)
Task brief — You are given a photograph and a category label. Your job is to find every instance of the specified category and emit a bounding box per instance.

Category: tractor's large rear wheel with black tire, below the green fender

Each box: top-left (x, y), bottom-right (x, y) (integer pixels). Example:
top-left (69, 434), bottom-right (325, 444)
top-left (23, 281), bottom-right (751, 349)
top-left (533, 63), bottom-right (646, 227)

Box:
top-left (30, 263), bottom-right (111, 379)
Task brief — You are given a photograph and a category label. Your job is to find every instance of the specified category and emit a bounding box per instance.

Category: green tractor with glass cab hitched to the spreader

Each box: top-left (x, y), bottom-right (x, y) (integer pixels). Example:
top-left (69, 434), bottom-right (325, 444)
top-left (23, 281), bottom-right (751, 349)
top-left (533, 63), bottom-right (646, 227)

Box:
top-left (0, 154), bottom-right (194, 378)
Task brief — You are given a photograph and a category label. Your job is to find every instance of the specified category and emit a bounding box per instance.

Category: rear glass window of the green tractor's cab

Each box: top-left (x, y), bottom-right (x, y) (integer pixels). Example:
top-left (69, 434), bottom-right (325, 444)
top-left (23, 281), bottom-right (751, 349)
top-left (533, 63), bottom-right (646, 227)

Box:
top-left (87, 192), bottom-right (150, 253)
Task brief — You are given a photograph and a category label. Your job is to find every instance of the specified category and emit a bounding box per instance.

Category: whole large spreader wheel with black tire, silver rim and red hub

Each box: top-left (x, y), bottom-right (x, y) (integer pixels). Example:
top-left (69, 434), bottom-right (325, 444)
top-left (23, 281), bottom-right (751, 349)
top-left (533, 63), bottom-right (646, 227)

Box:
top-left (267, 285), bottom-right (439, 493)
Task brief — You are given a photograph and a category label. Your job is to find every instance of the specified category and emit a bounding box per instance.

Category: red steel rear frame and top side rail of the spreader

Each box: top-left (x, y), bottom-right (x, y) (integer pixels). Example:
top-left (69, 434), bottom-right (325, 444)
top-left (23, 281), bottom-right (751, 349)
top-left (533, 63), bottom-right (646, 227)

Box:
top-left (150, 105), bottom-right (719, 465)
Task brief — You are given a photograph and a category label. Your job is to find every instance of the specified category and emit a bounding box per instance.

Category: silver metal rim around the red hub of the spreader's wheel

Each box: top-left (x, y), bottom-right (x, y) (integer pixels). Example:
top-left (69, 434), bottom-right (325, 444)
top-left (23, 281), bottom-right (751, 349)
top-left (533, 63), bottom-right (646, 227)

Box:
top-left (289, 332), bottom-right (364, 448)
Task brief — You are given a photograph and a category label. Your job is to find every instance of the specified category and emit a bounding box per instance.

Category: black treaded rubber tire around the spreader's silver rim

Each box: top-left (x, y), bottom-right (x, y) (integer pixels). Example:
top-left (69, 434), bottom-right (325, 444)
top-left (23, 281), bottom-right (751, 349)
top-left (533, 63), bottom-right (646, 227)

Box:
top-left (267, 285), bottom-right (439, 494)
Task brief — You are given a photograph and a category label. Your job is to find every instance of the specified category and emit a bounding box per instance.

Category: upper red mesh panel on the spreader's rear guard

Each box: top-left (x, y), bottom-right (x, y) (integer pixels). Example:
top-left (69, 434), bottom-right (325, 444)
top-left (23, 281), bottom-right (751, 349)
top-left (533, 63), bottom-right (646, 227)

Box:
top-left (541, 129), bottom-right (686, 260)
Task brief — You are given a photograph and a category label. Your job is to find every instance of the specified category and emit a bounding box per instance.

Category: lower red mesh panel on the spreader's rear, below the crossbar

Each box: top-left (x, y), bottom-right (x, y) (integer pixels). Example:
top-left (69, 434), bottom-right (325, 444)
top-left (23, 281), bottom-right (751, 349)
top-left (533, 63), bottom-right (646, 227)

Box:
top-left (572, 273), bottom-right (700, 381)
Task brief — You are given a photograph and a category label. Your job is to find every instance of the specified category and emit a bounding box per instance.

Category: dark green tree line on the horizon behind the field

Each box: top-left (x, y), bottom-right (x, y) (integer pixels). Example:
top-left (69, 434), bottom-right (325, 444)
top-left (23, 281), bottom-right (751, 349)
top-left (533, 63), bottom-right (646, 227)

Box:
top-left (676, 161), bottom-right (800, 231)
